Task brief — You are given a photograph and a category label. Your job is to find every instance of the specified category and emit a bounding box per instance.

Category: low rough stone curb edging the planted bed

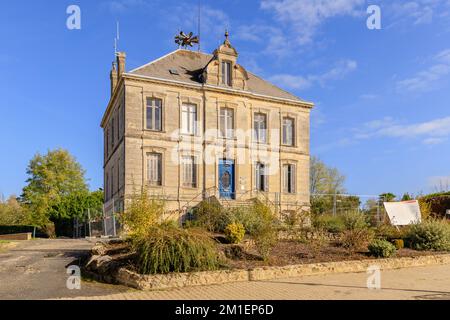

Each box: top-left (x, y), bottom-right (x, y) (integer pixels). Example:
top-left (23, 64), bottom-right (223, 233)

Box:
top-left (111, 254), bottom-right (450, 290)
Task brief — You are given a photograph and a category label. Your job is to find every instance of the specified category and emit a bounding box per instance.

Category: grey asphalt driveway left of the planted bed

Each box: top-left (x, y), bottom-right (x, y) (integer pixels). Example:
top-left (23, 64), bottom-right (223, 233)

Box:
top-left (0, 240), bottom-right (129, 300)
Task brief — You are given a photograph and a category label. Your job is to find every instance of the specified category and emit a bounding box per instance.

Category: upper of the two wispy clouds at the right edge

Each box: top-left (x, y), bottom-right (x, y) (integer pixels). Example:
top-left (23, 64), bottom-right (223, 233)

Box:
top-left (396, 49), bottom-right (450, 93)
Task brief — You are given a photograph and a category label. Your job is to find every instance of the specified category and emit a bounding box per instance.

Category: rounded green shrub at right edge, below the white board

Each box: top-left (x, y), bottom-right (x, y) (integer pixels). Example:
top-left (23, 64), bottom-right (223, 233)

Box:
top-left (405, 220), bottom-right (450, 251)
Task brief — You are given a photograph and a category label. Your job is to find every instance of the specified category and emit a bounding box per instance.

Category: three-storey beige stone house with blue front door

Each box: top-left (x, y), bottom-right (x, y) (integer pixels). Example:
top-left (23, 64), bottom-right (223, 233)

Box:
top-left (101, 31), bottom-right (313, 222)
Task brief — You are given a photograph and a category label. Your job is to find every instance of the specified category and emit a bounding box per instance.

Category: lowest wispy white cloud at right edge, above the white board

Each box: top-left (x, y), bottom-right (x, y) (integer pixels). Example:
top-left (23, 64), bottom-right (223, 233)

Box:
top-left (355, 117), bottom-right (450, 145)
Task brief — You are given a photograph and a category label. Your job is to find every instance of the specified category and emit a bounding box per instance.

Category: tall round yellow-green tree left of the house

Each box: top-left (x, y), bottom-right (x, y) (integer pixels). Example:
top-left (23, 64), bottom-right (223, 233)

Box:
top-left (21, 149), bottom-right (88, 227)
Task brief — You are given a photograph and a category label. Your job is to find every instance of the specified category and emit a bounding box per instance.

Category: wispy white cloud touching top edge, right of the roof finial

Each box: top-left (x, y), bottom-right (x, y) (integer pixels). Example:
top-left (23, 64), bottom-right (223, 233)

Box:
top-left (261, 0), bottom-right (365, 45)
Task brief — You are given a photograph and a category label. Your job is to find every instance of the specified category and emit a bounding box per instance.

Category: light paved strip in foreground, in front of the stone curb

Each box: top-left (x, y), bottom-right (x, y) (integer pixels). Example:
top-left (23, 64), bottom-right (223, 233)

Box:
top-left (70, 265), bottom-right (450, 300)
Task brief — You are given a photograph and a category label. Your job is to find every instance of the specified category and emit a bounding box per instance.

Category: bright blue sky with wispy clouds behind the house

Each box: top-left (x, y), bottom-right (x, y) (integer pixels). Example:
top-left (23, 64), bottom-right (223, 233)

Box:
top-left (0, 0), bottom-right (450, 196)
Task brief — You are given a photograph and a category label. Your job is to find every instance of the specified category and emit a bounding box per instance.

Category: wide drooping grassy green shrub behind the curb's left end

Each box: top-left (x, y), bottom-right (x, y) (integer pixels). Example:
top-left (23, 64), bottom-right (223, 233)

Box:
top-left (132, 224), bottom-right (219, 274)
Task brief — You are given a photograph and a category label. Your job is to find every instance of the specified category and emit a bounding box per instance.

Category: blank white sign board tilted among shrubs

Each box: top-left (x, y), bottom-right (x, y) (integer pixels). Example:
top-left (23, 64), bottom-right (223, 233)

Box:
top-left (384, 200), bottom-right (422, 226)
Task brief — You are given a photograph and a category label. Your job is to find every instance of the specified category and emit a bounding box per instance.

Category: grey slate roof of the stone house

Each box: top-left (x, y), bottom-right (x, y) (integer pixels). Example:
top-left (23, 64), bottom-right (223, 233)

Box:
top-left (129, 49), bottom-right (303, 102)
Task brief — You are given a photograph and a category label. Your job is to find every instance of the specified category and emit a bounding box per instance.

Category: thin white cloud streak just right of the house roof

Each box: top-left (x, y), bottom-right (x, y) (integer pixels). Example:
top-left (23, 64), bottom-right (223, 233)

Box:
top-left (269, 60), bottom-right (358, 90)
